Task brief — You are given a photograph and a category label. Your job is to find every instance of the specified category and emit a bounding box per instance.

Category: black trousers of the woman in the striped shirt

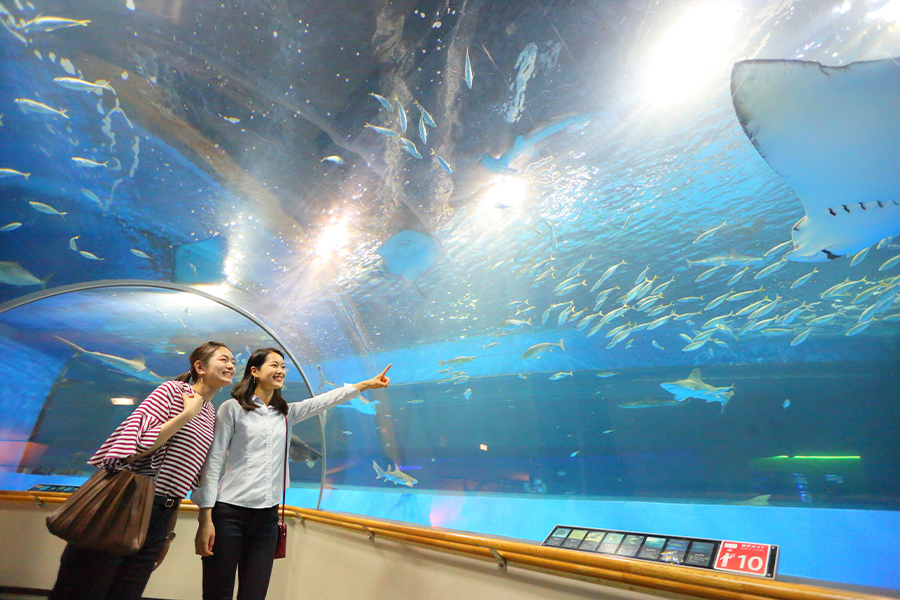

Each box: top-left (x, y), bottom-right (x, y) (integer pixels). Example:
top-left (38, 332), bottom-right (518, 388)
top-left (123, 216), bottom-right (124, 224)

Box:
top-left (49, 496), bottom-right (179, 600)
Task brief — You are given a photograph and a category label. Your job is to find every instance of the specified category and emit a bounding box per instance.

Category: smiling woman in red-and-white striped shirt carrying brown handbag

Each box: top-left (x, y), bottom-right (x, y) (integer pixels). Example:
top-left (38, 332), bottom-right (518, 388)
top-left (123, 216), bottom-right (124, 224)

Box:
top-left (50, 342), bottom-right (234, 600)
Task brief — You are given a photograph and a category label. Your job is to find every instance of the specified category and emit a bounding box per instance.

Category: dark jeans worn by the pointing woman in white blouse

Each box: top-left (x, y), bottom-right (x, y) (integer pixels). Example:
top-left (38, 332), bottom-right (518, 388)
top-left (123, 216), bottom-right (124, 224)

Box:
top-left (203, 502), bottom-right (278, 600)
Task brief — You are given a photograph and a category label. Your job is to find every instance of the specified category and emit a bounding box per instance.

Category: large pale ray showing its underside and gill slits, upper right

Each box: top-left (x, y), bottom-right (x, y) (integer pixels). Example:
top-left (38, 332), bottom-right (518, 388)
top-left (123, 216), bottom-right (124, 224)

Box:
top-left (731, 58), bottom-right (900, 262)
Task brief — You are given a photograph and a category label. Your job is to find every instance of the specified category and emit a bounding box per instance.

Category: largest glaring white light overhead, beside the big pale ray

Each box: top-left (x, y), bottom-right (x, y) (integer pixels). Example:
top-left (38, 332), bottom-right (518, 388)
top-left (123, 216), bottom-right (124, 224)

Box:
top-left (648, 3), bottom-right (738, 104)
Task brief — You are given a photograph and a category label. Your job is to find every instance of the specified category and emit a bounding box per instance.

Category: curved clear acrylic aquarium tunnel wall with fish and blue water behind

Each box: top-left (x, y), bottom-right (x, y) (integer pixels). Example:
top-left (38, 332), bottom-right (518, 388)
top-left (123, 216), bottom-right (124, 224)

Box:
top-left (0, 0), bottom-right (900, 590)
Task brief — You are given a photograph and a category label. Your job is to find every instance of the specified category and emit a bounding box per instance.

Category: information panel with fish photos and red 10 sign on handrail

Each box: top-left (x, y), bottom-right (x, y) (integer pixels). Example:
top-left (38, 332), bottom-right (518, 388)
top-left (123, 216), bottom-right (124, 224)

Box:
top-left (542, 525), bottom-right (778, 579)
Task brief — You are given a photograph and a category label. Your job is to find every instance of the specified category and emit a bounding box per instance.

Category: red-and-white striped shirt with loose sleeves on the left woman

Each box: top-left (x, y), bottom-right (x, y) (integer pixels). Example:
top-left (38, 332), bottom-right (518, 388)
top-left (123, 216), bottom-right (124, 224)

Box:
top-left (88, 381), bottom-right (216, 498)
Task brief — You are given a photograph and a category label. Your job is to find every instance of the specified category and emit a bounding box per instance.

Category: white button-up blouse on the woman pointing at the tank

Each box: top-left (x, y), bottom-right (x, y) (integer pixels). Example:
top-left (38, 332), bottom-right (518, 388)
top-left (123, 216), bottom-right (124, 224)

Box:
top-left (191, 384), bottom-right (359, 508)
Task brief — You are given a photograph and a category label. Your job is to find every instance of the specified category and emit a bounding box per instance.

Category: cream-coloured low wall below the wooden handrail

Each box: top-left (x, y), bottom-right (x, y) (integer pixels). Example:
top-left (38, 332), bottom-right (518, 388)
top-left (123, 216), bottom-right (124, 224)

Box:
top-left (0, 501), bottom-right (684, 600)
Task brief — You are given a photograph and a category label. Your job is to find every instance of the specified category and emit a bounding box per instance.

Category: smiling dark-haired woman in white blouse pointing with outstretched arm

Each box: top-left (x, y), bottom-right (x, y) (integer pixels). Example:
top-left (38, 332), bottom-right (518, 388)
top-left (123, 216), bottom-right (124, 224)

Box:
top-left (191, 348), bottom-right (391, 600)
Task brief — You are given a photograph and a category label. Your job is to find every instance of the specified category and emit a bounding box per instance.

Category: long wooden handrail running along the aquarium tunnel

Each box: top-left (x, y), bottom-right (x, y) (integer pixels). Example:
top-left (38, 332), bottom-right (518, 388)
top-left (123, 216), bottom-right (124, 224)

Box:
top-left (0, 491), bottom-right (889, 600)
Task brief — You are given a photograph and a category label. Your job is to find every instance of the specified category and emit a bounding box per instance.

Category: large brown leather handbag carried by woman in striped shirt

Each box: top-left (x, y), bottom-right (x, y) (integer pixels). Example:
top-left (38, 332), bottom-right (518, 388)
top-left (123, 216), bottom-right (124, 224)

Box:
top-left (47, 469), bottom-right (156, 556)
